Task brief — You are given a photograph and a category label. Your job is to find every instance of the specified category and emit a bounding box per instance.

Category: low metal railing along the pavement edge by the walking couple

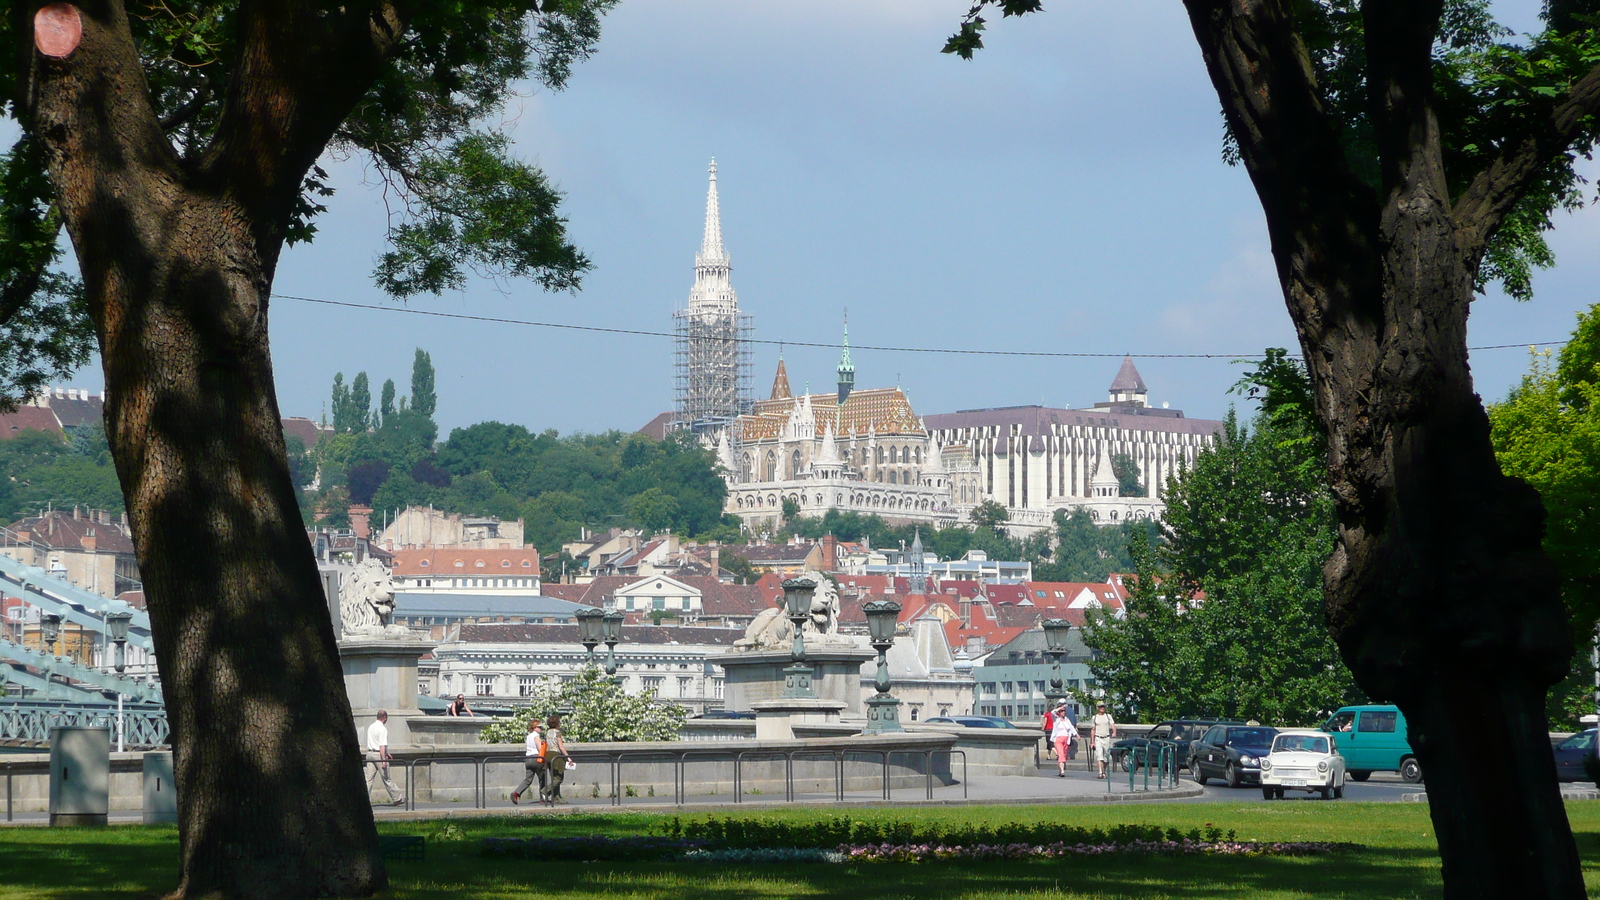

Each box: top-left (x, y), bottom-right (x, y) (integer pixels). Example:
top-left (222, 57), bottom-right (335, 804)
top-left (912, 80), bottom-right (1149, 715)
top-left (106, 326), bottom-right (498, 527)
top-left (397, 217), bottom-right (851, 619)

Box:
top-left (393, 748), bottom-right (970, 810)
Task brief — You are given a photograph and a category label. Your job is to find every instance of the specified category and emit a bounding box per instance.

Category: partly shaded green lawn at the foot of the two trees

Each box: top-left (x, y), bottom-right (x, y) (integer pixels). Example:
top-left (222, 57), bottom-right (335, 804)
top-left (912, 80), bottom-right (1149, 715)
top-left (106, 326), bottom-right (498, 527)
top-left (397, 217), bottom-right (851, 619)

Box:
top-left (0, 801), bottom-right (1600, 900)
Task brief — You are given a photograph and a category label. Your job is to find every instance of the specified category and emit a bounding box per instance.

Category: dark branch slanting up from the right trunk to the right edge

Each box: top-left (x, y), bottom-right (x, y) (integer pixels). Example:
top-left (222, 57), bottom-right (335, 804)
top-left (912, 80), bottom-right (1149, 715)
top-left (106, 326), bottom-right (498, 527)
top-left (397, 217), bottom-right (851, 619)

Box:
top-left (1451, 59), bottom-right (1600, 259)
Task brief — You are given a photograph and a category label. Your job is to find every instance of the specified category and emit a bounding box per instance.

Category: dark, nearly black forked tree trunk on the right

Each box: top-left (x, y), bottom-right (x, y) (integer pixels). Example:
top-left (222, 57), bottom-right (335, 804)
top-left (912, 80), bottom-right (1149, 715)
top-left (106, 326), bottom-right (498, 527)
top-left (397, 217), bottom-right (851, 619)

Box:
top-left (1186, 0), bottom-right (1584, 900)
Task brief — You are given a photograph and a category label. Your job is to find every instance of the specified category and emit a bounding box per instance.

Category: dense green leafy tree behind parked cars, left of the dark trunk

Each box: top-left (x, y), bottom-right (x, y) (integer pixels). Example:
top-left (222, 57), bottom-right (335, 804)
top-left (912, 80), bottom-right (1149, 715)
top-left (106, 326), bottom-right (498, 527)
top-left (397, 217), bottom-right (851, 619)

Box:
top-left (1085, 357), bottom-right (1360, 725)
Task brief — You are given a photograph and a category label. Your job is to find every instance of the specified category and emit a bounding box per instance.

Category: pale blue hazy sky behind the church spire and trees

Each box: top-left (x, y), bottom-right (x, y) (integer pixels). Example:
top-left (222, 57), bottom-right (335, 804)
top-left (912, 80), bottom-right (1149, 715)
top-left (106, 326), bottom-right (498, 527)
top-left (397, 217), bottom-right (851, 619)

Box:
top-left (46, 0), bottom-right (1600, 436)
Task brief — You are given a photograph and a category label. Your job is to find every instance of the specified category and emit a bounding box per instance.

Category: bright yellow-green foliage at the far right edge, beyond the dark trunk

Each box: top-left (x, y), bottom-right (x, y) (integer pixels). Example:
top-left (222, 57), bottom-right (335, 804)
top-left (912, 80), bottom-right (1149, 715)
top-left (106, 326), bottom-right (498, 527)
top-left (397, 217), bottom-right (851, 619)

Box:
top-left (1488, 318), bottom-right (1600, 727)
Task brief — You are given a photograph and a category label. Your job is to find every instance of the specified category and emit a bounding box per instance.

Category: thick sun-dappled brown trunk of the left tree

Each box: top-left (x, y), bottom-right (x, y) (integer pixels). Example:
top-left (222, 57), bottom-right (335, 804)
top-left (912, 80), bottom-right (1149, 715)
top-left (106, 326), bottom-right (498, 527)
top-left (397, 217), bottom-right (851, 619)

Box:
top-left (21, 0), bottom-right (398, 897)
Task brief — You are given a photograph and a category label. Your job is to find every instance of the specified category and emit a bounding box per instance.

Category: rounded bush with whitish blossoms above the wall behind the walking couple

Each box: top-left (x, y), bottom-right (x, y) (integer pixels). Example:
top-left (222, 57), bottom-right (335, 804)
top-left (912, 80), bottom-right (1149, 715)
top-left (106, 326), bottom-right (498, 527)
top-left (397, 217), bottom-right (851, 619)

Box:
top-left (478, 666), bottom-right (688, 743)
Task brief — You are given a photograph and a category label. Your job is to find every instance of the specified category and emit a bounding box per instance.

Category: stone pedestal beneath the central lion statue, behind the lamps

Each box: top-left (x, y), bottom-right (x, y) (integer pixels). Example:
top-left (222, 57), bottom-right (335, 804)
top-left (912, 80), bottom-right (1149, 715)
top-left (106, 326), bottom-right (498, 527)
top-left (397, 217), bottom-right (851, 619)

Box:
top-left (709, 639), bottom-right (878, 714)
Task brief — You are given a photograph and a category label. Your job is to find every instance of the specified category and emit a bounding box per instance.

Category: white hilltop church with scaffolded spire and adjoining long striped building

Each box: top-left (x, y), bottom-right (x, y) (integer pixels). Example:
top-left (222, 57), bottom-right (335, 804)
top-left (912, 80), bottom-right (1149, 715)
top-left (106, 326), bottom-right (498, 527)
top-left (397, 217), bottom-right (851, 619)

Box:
top-left (661, 160), bottom-right (1222, 533)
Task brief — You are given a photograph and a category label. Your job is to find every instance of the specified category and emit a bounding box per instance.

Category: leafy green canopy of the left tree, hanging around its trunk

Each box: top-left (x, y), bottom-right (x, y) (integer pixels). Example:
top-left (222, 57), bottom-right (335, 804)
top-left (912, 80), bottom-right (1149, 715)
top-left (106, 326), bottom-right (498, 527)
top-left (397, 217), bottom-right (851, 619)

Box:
top-left (0, 0), bottom-right (616, 400)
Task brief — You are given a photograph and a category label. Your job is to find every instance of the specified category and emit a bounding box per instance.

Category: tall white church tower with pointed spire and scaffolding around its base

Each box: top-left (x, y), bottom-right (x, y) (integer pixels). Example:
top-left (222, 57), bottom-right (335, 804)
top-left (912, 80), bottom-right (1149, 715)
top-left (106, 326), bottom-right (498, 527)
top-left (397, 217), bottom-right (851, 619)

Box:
top-left (672, 160), bottom-right (754, 431)
